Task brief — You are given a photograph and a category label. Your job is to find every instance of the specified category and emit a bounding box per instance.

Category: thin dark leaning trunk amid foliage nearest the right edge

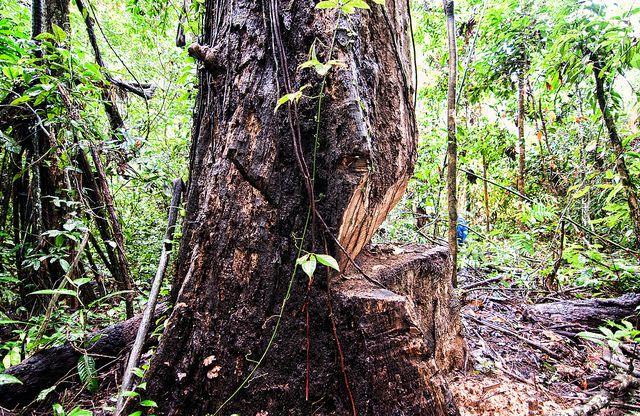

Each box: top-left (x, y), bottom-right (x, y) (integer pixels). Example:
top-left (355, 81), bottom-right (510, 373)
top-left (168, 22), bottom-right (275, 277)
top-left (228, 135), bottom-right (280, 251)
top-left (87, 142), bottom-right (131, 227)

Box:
top-left (593, 60), bottom-right (640, 245)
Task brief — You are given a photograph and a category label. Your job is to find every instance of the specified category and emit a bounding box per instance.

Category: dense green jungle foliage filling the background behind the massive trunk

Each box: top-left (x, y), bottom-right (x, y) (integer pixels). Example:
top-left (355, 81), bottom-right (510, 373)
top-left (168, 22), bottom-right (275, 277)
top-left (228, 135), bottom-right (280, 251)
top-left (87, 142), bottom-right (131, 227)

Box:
top-left (0, 0), bottom-right (640, 416)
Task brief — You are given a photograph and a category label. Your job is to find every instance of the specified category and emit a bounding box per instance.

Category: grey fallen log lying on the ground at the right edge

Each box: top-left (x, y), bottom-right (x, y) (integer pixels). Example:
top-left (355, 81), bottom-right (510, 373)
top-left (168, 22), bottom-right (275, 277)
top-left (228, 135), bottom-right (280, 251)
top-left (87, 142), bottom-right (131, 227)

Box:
top-left (527, 293), bottom-right (640, 327)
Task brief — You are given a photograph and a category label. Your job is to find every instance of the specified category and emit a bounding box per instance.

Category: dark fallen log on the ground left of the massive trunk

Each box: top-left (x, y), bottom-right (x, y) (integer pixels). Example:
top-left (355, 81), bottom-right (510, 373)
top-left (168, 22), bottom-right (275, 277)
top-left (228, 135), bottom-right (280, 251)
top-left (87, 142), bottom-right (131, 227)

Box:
top-left (0, 304), bottom-right (167, 409)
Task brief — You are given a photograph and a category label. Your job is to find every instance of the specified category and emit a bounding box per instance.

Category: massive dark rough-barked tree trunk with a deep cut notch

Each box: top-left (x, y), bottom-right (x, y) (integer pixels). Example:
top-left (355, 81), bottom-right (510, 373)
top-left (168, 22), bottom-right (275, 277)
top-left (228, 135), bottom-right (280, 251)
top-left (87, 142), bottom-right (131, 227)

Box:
top-left (147, 0), bottom-right (458, 415)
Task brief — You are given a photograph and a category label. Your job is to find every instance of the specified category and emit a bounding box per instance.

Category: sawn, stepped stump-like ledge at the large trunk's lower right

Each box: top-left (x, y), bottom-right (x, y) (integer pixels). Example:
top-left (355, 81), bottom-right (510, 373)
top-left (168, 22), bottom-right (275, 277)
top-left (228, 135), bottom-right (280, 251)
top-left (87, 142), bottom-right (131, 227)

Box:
top-left (333, 245), bottom-right (465, 415)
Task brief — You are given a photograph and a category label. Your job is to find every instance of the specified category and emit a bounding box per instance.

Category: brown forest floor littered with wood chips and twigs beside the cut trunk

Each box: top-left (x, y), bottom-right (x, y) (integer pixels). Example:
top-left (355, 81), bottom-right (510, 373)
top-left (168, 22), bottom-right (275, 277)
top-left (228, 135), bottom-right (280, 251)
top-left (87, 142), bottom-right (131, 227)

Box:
top-left (449, 270), bottom-right (640, 416)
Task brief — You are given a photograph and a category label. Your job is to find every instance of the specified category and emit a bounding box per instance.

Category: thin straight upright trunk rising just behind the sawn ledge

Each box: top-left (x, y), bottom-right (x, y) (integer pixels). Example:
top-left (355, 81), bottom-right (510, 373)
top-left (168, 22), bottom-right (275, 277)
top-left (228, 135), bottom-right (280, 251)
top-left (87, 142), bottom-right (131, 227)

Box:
top-left (443, 0), bottom-right (458, 287)
